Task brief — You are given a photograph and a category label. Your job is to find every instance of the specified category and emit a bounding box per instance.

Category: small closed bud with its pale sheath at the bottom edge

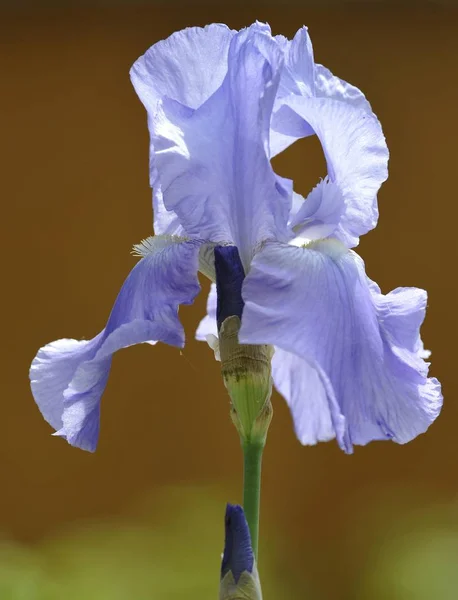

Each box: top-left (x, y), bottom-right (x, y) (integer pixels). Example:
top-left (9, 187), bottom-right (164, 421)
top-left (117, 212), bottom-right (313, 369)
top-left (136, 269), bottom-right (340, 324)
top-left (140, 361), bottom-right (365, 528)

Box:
top-left (219, 504), bottom-right (262, 600)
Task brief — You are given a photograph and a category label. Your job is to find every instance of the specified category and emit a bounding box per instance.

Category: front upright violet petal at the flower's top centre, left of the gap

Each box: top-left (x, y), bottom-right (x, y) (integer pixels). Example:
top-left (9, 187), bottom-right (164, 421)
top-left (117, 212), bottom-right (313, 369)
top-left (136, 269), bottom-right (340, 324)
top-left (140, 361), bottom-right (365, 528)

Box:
top-left (133, 24), bottom-right (291, 267)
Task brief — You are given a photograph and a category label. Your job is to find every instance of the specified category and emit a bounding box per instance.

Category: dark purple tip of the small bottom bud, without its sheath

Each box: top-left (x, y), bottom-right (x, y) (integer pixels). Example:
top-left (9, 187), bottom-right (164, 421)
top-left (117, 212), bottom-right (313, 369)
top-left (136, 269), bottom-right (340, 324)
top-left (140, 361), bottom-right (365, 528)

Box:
top-left (221, 504), bottom-right (254, 583)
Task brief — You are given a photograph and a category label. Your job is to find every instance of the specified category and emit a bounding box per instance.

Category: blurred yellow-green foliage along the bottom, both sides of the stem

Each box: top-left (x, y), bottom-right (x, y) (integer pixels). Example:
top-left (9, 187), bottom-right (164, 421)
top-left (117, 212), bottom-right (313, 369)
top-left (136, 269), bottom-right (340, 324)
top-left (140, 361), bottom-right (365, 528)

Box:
top-left (0, 487), bottom-right (458, 600)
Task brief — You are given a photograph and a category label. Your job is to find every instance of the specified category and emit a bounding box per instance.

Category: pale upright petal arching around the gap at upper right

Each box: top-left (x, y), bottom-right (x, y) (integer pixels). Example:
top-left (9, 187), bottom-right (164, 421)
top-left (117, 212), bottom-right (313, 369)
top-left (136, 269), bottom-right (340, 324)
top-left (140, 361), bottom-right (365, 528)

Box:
top-left (271, 27), bottom-right (388, 248)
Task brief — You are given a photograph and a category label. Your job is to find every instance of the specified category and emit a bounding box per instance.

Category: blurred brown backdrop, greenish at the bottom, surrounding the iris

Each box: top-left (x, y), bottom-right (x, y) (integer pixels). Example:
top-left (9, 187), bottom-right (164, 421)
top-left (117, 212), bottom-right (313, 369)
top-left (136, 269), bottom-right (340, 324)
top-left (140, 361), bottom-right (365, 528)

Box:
top-left (0, 1), bottom-right (458, 600)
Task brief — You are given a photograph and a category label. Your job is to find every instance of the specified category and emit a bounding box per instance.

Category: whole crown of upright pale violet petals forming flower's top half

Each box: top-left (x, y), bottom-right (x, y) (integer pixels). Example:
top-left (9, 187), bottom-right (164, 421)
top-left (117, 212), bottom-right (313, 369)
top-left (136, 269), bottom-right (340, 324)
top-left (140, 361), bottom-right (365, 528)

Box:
top-left (131, 22), bottom-right (388, 248)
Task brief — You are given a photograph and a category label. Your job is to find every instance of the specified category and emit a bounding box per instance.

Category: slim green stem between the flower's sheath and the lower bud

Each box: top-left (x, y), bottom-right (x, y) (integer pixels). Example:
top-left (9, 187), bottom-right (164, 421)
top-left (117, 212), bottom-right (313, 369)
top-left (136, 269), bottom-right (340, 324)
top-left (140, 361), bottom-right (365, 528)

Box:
top-left (242, 440), bottom-right (264, 560)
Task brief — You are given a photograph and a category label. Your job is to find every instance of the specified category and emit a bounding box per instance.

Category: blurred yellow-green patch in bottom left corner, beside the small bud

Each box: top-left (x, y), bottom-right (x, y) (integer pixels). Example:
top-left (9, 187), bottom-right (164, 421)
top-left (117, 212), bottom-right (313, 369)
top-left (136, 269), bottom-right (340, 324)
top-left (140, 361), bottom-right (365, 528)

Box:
top-left (0, 488), bottom-right (296, 600)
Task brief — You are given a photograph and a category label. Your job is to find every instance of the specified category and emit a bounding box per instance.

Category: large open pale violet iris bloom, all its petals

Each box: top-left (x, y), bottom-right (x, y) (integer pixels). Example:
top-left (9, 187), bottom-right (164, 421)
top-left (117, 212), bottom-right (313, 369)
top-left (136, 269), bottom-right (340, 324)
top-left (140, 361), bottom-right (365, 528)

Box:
top-left (30, 23), bottom-right (442, 452)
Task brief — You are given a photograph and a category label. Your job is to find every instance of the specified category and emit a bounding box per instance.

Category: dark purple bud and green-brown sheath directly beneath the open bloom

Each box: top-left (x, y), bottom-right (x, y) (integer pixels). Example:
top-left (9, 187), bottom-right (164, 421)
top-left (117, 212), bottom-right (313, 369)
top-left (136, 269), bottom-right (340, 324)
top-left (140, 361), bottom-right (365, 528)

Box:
top-left (215, 246), bottom-right (273, 444)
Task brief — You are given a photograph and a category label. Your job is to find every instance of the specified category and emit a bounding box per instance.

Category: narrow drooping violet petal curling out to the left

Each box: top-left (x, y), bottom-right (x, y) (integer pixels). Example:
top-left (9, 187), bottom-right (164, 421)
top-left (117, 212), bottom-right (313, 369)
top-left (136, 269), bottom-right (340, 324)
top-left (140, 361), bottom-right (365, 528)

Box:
top-left (30, 236), bottom-right (200, 451)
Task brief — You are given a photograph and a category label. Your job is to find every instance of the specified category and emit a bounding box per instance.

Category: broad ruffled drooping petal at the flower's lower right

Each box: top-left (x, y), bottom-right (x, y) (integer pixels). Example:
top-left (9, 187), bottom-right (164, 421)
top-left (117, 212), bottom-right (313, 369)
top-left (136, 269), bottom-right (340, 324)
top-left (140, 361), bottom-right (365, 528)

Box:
top-left (239, 240), bottom-right (442, 451)
